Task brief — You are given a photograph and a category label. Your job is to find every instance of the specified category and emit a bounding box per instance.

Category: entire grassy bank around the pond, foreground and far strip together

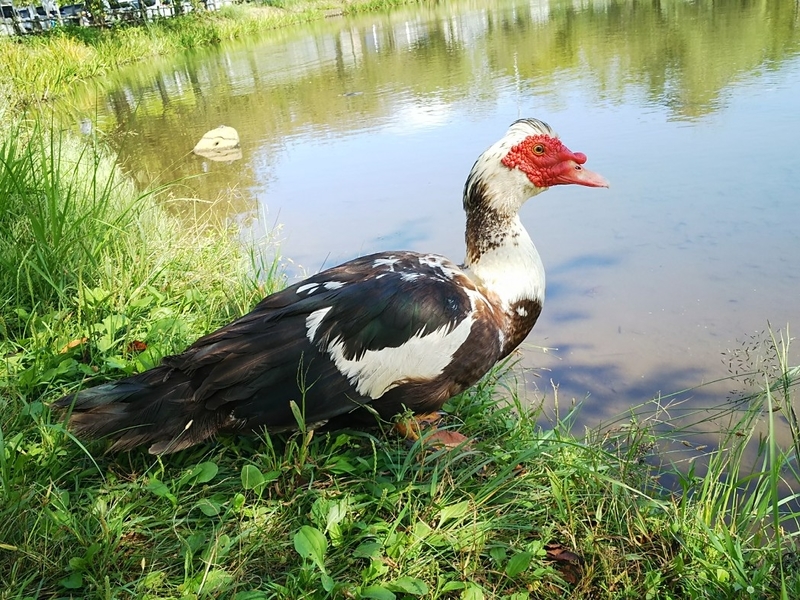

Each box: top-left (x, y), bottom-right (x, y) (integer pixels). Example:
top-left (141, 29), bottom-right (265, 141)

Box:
top-left (0, 4), bottom-right (800, 600)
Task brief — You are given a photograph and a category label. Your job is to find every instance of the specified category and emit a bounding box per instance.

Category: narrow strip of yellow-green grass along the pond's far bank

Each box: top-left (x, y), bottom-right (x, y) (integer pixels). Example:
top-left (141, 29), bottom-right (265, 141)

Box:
top-left (0, 0), bottom-right (422, 106)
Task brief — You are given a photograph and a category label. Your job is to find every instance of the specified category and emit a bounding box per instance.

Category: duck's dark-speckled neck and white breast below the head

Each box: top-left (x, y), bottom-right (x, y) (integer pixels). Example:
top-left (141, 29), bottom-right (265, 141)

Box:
top-left (464, 210), bottom-right (545, 356)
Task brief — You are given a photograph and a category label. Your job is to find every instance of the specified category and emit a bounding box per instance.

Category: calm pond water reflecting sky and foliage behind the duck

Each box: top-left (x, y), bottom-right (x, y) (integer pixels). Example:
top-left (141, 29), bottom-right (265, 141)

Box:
top-left (62, 0), bottom-right (800, 440)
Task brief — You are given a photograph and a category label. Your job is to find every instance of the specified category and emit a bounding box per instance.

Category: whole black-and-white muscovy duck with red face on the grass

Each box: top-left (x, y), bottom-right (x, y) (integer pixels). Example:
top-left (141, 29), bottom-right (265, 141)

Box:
top-left (55, 119), bottom-right (608, 454)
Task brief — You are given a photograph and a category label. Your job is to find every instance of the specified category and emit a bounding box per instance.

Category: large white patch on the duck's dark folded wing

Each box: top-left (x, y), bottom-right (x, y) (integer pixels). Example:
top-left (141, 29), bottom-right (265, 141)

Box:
top-left (324, 309), bottom-right (475, 400)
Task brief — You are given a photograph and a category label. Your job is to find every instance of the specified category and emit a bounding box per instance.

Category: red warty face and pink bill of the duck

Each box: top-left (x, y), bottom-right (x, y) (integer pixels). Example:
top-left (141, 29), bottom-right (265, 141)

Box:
top-left (501, 134), bottom-right (608, 188)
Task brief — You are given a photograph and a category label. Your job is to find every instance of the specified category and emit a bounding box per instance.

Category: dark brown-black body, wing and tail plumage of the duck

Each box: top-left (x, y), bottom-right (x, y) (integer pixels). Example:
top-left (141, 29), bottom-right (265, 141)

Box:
top-left (56, 253), bottom-right (501, 452)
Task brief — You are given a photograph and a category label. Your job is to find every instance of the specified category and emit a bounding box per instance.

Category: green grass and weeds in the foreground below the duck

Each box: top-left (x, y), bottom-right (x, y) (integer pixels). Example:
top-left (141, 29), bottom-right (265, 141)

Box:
top-left (0, 344), bottom-right (800, 599)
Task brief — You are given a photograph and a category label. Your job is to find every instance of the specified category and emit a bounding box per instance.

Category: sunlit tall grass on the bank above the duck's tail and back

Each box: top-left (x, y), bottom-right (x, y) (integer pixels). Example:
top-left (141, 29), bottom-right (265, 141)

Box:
top-left (0, 117), bottom-right (276, 394)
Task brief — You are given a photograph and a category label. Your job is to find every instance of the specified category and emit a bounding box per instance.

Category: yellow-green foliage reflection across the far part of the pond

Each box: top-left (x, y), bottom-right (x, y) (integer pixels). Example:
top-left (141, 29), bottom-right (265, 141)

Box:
top-left (69, 0), bottom-right (800, 199)
